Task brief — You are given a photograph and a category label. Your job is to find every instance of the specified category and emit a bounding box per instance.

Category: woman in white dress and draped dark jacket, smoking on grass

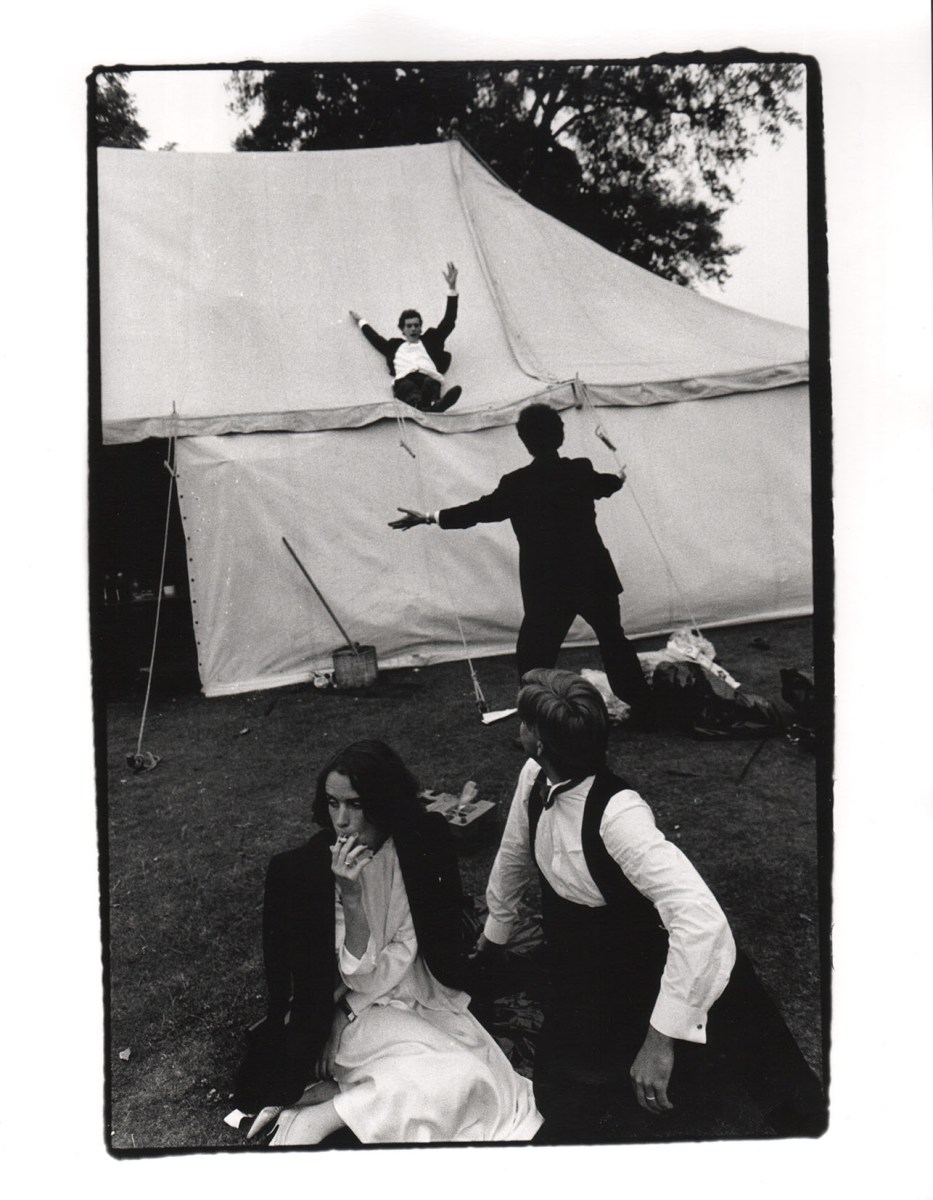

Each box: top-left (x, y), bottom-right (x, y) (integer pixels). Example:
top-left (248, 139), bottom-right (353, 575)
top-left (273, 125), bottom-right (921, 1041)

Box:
top-left (229, 740), bottom-right (542, 1146)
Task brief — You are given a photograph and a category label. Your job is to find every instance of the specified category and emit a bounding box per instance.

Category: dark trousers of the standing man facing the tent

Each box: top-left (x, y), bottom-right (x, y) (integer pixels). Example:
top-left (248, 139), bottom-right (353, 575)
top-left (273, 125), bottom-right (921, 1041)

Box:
top-left (516, 592), bottom-right (651, 716)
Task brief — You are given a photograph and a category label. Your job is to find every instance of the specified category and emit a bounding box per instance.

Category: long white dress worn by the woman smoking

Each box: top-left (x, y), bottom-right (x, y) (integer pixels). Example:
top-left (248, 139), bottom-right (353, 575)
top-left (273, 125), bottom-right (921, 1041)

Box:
top-left (292, 839), bottom-right (543, 1144)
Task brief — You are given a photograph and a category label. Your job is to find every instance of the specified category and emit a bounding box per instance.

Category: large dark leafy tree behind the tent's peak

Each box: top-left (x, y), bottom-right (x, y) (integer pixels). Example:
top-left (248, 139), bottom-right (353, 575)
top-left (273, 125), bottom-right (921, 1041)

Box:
top-left (230, 61), bottom-right (803, 283)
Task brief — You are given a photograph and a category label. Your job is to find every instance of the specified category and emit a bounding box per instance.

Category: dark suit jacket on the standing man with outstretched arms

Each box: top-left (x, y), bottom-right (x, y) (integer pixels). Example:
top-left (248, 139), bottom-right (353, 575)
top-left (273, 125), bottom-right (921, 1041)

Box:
top-left (438, 451), bottom-right (622, 610)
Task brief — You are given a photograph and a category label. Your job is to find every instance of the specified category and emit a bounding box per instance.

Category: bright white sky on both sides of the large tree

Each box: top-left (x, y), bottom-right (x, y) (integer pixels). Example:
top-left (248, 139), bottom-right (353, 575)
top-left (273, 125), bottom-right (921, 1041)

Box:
top-left (127, 71), bottom-right (809, 326)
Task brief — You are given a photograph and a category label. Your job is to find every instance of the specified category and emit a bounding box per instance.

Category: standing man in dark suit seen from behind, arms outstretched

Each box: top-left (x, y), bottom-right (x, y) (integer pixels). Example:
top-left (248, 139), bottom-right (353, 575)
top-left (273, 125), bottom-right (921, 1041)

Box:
top-left (390, 404), bottom-right (654, 727)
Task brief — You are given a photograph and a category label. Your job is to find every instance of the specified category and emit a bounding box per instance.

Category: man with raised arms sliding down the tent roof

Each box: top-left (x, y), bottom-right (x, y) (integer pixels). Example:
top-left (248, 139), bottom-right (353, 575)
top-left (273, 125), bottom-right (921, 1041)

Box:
top-left (350, 263), bottom-right (463, 413)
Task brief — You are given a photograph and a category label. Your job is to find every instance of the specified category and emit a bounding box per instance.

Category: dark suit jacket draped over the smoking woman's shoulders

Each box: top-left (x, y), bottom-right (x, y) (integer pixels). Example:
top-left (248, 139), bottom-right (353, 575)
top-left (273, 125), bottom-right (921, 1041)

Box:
top-left (234, 812), bottom-right (469, 1112)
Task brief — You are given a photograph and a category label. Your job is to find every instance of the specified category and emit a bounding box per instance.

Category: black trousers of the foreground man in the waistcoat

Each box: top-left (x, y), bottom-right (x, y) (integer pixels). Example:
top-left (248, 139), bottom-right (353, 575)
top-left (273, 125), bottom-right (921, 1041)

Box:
top-left (534, 880), bottom-right (826, 1141)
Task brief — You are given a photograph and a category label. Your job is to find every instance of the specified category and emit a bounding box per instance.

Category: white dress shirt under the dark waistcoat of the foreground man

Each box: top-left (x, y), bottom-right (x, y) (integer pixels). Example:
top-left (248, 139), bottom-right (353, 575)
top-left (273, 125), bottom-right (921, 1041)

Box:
top-left (483, 758), bottom-right (735, 1043)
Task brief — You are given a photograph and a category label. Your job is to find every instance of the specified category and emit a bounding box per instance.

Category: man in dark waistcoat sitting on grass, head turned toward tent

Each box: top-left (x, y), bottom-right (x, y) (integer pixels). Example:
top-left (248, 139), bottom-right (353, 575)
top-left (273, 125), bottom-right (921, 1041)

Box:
top-left (477, 668), bottom-right (825, 1140)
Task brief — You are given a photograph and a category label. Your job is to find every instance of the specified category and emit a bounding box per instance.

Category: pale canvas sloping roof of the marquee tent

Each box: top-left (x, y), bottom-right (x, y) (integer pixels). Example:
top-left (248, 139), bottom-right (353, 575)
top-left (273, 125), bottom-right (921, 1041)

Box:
top-left (98, 142), bottom-right (807, 443)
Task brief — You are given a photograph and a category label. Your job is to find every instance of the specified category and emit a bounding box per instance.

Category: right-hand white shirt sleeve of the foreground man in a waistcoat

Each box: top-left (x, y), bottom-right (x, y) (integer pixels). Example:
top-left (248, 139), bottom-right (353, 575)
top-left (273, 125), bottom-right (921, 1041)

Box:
top-left (600, 791), bottom-right (735, 1043)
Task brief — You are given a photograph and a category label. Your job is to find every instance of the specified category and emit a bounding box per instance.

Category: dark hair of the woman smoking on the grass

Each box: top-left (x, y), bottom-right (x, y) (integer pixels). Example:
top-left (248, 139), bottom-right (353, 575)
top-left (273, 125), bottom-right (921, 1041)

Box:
top-left (311, 738), bottom-right (421, 838)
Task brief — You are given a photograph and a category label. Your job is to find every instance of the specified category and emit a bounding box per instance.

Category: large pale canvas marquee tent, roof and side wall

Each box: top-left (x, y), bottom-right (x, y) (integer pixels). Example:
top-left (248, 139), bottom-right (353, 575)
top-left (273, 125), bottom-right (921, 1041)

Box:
top-left (98, 142), bottom-right (812, 695)
